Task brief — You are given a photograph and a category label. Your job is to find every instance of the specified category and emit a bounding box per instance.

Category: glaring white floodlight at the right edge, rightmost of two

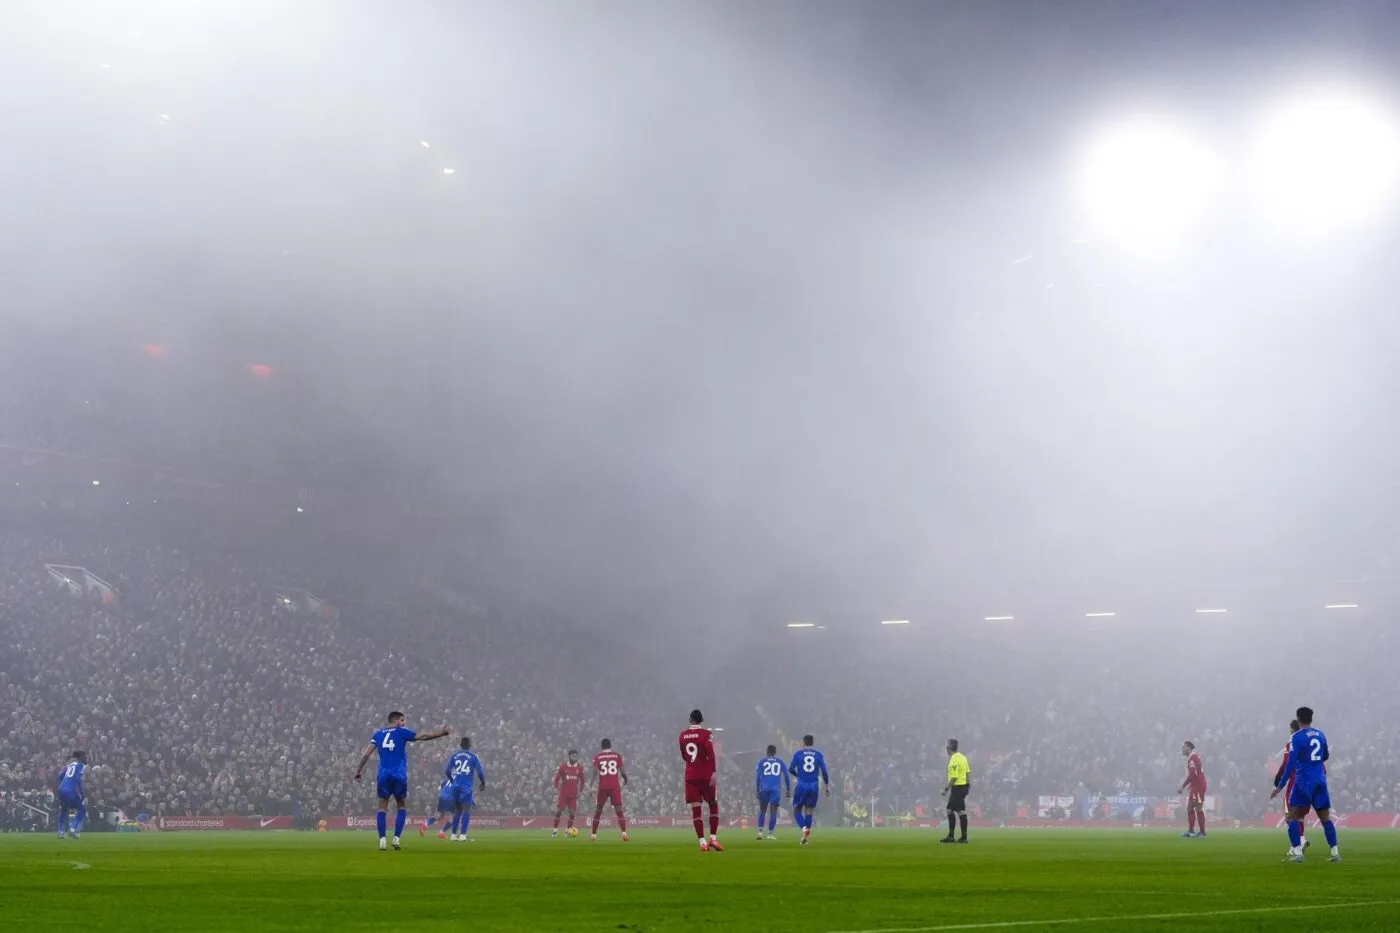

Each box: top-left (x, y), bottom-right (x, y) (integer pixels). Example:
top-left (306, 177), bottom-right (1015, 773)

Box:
top-left (1250, 90), bottom-right (1400, 235)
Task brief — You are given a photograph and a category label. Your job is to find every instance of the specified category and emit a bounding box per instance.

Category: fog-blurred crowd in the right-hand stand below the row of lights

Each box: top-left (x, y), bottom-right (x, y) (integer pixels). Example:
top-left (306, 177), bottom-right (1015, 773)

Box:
top-left (734, 621), bottom-right (1400, 818)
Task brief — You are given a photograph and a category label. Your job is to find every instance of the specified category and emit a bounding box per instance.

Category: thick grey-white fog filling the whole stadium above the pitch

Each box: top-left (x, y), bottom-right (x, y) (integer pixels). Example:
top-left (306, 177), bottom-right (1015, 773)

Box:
top-left (8, 0), bottom-right (1400, 851)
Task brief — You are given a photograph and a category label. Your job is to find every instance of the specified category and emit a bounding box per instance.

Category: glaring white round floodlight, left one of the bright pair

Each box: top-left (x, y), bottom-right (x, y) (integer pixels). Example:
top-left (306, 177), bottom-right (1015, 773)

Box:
top-left (1078, 116), bottom-right (1221, 249)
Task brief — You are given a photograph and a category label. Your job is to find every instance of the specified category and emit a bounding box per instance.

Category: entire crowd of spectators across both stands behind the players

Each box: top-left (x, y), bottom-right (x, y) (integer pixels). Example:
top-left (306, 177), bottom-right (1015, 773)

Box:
top-left (0, 523), bottom-right (1400, 828)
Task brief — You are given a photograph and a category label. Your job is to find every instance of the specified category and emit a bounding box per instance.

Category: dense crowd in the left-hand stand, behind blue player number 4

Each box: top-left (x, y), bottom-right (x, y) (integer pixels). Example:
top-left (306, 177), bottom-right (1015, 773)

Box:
top-left (0, 523), bottom-right (686, 815)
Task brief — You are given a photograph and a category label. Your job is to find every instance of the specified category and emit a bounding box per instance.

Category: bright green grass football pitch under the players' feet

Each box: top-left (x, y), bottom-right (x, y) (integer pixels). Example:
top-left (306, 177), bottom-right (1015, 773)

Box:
top-left (0, 828), bottom-right (1400, 933)
